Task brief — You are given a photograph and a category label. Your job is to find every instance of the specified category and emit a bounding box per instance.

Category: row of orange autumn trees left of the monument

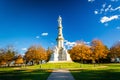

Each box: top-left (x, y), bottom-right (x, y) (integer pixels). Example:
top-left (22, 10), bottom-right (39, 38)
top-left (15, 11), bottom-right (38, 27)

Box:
top-left (0, 46), bottom-right (52, 67)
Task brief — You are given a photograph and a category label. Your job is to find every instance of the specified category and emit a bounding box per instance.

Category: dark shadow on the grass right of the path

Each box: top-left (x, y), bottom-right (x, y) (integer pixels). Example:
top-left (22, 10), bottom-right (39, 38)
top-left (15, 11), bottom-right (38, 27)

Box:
top-left (71, 69), bottom-right (120, 80)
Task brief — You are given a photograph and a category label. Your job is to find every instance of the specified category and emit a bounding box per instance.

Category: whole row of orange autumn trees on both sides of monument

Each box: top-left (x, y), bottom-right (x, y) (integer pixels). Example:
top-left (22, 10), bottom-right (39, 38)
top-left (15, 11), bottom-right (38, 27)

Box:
top-left (0, 39), bottom-right (120, 66)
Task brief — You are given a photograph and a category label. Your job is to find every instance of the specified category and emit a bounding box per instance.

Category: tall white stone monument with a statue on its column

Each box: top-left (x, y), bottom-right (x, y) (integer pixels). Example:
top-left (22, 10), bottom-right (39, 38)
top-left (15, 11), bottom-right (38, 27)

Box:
top-left (50, 16), bottom-right (72, 62)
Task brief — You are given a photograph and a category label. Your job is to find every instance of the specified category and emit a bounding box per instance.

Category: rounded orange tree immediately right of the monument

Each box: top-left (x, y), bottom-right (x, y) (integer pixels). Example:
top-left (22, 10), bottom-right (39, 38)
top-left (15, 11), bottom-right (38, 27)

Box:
top-left (69, 42), bottom-right (91, 62)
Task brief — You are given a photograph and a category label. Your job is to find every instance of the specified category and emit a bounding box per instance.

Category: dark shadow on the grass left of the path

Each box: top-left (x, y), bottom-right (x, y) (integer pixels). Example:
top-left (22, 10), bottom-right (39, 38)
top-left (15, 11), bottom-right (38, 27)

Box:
top-left (0, 69), bottom-right (50, 80)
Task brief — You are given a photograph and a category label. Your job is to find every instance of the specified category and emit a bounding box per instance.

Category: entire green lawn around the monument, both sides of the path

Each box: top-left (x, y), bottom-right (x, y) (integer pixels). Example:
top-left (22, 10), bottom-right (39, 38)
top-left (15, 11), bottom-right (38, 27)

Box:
top-left (0, 63), bottom-right (120, 80)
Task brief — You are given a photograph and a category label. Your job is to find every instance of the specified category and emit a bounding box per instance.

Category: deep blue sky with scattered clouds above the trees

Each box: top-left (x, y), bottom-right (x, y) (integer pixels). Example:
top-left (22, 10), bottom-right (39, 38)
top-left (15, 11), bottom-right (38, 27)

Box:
top-left (0, 0), bottom-right (120, 53)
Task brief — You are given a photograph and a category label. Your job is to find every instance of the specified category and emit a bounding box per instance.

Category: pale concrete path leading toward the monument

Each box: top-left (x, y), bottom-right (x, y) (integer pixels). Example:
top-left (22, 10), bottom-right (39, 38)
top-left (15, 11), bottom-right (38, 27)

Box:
top-left (47, 69), bottom-right (75, 80)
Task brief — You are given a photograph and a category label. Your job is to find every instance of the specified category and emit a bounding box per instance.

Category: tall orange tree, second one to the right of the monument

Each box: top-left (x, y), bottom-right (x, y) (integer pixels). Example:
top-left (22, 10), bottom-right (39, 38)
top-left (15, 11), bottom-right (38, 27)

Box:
top-left (91, 39), bottom-right (108, 63)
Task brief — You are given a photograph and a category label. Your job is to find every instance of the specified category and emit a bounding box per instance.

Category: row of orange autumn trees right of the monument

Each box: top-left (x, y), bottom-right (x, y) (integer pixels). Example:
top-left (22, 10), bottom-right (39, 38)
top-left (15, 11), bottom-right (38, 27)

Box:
top-left (69, 39), bottom-right (120, 63)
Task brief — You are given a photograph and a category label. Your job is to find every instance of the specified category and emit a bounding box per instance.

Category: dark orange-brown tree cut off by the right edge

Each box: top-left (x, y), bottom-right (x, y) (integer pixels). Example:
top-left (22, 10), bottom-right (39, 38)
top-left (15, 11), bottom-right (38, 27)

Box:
top-left (109, 41), bottom-right (120, 62)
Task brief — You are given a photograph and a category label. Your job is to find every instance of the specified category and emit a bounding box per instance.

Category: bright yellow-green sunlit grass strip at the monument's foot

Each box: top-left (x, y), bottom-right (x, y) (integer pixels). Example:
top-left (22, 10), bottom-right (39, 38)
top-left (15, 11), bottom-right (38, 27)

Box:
top-left (26, 62), bottom-right (102, 69)
